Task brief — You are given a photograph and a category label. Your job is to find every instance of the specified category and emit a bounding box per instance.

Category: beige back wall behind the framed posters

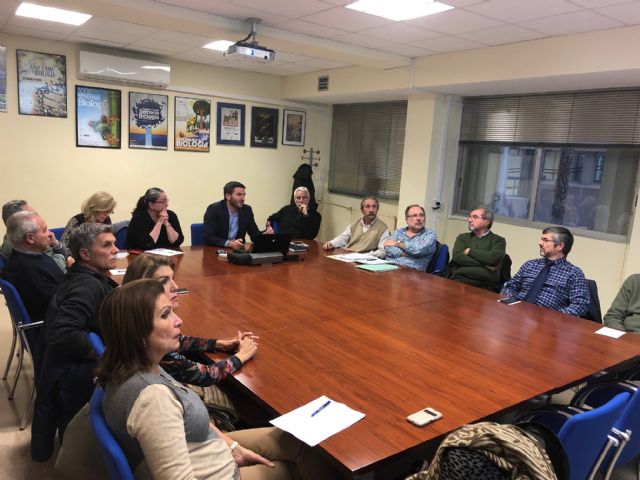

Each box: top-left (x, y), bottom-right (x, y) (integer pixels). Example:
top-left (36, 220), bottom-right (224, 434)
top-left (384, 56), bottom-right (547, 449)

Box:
top-left (0, 35), bottom-right (330, 244)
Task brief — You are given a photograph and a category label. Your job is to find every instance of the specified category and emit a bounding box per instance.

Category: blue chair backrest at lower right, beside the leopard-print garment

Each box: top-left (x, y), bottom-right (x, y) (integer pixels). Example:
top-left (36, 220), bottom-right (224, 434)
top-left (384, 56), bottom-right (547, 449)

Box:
top-left (558, 393), bottom-right (630, 480)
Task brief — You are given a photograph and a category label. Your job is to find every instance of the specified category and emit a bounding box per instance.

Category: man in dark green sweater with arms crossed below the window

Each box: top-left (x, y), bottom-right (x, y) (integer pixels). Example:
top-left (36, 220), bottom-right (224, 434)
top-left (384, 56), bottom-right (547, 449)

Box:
top-left (449, 207), bottom-right (507, 292)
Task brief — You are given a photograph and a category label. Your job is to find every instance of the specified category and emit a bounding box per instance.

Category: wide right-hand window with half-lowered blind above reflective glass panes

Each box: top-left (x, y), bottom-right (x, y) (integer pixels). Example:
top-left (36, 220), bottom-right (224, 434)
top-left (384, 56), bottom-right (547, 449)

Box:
top-left (456, 90), bottom-right (640, 240)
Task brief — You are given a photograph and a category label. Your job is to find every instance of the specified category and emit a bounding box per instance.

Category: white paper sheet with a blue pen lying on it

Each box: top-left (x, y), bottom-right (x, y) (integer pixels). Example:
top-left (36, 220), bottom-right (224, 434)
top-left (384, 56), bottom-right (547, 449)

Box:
top-left (270, 395), bottom-right (365, 447)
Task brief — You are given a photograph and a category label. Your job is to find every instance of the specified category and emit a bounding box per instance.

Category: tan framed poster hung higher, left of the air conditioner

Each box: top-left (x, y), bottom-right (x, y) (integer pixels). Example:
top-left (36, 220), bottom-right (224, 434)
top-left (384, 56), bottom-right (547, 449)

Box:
top-left (16, 50), bottom-right (67, 118)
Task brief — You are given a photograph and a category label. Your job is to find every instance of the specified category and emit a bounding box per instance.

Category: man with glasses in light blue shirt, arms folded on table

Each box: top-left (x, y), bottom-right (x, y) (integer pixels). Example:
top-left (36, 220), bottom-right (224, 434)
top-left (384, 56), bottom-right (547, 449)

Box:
top-left (384, 205), bottom-right (436, 272)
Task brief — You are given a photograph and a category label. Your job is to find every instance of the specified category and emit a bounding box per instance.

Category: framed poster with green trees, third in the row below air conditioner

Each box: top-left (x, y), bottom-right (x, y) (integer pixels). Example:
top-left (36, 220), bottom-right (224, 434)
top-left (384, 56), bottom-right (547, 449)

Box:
top-left (173, 97), bottom-right (211, 152)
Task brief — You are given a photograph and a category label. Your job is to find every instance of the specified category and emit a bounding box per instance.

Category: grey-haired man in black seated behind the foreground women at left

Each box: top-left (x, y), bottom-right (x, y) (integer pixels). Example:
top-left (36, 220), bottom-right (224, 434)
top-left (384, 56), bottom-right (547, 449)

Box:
top-left (31, 223), bottom-right (118, 462)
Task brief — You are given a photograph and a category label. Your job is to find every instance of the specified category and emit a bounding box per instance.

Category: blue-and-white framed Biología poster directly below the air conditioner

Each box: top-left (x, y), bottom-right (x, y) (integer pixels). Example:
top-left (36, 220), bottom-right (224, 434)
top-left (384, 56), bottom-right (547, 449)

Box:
top-left (76, 85), bottom-right (122, 148)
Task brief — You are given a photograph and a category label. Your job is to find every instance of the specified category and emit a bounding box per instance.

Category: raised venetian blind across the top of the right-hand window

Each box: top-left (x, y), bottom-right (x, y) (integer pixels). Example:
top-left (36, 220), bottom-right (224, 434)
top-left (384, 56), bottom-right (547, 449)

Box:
top-left (460, 90), bottom-right (640, 145)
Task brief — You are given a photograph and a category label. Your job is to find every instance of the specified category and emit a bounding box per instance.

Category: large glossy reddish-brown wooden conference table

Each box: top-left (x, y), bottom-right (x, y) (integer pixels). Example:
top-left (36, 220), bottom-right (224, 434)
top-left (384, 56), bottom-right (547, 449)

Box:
top-left (130, 246), bottom-right (640, 478)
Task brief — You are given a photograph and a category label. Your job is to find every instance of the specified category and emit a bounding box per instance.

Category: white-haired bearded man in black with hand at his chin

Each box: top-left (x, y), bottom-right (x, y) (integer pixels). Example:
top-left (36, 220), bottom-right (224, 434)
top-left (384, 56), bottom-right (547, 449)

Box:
top-left (267, 187), bottom-right (322, 240)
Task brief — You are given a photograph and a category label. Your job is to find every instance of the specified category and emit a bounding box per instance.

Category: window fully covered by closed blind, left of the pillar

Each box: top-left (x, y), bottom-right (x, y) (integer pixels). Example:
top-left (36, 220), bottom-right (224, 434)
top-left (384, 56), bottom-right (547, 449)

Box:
top-left (329, 101), bottom-right (407, 200)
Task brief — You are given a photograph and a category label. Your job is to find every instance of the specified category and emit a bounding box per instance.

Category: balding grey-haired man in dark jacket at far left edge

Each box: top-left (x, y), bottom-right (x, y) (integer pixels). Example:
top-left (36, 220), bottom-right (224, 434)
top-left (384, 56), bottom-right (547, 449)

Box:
top-left (2, 211), bottom-right (64, 328)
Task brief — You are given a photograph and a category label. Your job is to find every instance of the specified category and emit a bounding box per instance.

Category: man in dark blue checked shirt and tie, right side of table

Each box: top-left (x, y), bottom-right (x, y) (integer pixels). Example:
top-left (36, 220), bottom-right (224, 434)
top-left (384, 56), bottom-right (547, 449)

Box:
top-left (503, 227), bottom-right (590, 317)
